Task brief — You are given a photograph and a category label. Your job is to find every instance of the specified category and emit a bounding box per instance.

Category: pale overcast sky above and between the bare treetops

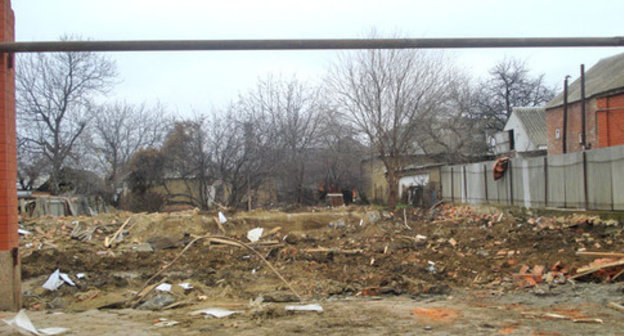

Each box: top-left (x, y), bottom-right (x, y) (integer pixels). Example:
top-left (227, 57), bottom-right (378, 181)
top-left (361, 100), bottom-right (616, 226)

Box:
top-left (13, 0), bottom-right (624, 114)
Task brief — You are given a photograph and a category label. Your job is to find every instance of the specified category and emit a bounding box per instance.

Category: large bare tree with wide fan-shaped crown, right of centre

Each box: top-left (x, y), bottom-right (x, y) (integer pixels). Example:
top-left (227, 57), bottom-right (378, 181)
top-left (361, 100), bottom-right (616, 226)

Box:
top-left (328, 50), bottom-right (451, 208)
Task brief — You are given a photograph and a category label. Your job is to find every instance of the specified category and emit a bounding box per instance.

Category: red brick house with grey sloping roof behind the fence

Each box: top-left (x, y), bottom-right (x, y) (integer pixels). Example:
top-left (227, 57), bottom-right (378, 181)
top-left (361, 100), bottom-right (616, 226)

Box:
top-left (546, 53), bottom-right (624, 155)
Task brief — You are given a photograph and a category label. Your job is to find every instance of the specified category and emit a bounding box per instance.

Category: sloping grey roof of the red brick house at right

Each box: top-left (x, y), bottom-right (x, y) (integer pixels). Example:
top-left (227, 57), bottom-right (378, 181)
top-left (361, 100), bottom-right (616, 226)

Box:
top-left (546, 53), bottom-right (624, 109)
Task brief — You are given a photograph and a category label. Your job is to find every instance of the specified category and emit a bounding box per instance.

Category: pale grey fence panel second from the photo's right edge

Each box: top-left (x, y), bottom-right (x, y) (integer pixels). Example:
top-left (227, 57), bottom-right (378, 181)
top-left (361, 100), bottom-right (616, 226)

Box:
top-left (587, 147), bottom-right (614, 210)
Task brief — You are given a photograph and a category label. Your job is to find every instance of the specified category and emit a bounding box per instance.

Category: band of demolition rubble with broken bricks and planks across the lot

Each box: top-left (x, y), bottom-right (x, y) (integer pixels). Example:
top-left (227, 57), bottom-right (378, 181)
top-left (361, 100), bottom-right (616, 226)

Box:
top-left (7, 203), bottom-right (624, 330)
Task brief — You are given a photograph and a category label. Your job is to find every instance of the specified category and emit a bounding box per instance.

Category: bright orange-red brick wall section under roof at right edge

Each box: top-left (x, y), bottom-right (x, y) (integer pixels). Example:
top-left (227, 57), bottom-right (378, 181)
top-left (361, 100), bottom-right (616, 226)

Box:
top-left (597, 94), bottom-right (624, 147)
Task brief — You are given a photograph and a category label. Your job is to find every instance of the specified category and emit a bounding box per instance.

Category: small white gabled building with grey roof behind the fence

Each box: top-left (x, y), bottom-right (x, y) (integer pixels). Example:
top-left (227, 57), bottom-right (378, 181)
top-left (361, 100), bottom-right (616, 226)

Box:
top-left (494, 107), bottom-right (548, 157)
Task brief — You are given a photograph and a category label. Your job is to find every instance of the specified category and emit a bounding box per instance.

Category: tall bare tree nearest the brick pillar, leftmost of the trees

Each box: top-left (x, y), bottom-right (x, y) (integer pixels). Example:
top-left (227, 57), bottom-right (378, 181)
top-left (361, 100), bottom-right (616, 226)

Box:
top-left (16, 44), bottom-right (116, 193)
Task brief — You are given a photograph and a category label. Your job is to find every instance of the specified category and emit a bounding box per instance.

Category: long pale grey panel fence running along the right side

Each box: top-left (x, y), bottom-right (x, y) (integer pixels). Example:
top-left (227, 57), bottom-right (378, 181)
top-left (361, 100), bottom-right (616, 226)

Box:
top-left (442, 145), bottom-right (624, 210)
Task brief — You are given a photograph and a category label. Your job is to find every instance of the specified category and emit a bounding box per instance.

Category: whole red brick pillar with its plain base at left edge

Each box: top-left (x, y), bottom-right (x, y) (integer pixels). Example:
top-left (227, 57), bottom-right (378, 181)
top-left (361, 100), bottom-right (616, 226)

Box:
top-left (0, 0), bottom-right (21, 310)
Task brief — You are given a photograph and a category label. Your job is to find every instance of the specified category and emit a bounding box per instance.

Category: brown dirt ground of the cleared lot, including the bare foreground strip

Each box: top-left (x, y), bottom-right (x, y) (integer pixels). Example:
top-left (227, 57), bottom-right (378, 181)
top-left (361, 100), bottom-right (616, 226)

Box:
top-left (0, 205), bottom-right (624, 335)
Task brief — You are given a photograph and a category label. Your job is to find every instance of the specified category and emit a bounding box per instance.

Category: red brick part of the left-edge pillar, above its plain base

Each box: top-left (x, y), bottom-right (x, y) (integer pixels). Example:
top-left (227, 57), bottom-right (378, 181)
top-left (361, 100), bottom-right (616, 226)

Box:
top-left (0, 0), bottom-right (18, 251)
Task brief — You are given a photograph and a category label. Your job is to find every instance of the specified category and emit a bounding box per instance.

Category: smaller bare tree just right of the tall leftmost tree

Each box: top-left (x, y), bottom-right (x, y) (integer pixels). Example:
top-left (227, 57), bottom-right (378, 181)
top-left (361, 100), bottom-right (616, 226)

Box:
top-left (90, 102), bottom-right (169, 201)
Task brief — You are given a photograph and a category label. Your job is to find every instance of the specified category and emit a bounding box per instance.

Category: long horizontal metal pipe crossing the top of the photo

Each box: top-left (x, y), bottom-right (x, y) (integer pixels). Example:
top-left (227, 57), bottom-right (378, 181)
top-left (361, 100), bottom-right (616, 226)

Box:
top-left (0, 36), bottom-right (624, 53)
